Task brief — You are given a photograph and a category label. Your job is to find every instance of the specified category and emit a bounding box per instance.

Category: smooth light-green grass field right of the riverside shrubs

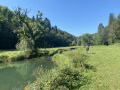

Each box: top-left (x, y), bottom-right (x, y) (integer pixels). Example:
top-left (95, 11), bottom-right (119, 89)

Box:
top-left (81, 44), bottom-right (120, 90)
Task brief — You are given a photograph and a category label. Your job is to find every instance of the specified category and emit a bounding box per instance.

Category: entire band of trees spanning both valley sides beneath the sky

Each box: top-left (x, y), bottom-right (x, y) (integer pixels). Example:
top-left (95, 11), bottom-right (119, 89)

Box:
top-left (0, 6), bottom-right (120, 50)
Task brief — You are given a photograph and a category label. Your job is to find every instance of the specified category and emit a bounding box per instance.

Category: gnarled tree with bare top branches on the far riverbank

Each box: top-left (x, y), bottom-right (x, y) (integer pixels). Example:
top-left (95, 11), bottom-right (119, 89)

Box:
top-left (15, 7), bottom-right (41, 51)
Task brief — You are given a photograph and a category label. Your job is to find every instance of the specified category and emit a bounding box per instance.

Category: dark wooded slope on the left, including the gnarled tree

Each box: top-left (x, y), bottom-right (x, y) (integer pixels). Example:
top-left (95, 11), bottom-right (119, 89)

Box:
top-left (0, 6), bottom-right (76, 50)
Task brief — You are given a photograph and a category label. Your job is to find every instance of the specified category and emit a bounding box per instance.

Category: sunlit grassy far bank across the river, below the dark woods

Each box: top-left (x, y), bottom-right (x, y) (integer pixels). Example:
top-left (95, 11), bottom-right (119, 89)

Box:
top-left (0, 46), bottom-right (78, 63)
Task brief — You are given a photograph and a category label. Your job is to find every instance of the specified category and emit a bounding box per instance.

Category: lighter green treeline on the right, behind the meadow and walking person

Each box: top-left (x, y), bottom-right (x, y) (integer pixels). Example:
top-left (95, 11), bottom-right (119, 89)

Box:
top-left (72, 13), bottom-right (120, 45)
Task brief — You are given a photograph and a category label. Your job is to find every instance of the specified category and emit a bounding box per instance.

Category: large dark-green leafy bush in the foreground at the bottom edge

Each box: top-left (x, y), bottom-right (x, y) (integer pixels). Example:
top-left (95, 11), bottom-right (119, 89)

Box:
top-left (50, 67), bottom-right (89, 90)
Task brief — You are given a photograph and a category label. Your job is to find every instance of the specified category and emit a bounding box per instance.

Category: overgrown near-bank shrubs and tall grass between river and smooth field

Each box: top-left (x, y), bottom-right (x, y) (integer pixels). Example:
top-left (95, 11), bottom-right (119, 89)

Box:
top-left (26, 47), bottom-right (94, 90)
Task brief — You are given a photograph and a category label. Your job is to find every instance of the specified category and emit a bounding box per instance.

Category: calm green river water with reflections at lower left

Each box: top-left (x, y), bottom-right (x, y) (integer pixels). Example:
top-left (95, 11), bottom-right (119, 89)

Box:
top-left (0, 57), bottom-right (54, 90)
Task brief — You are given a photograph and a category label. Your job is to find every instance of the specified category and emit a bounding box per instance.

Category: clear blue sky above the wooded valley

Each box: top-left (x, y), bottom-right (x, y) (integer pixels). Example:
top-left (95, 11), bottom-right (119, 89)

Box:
top-left (0, 0), bottom-right (120, 36)
